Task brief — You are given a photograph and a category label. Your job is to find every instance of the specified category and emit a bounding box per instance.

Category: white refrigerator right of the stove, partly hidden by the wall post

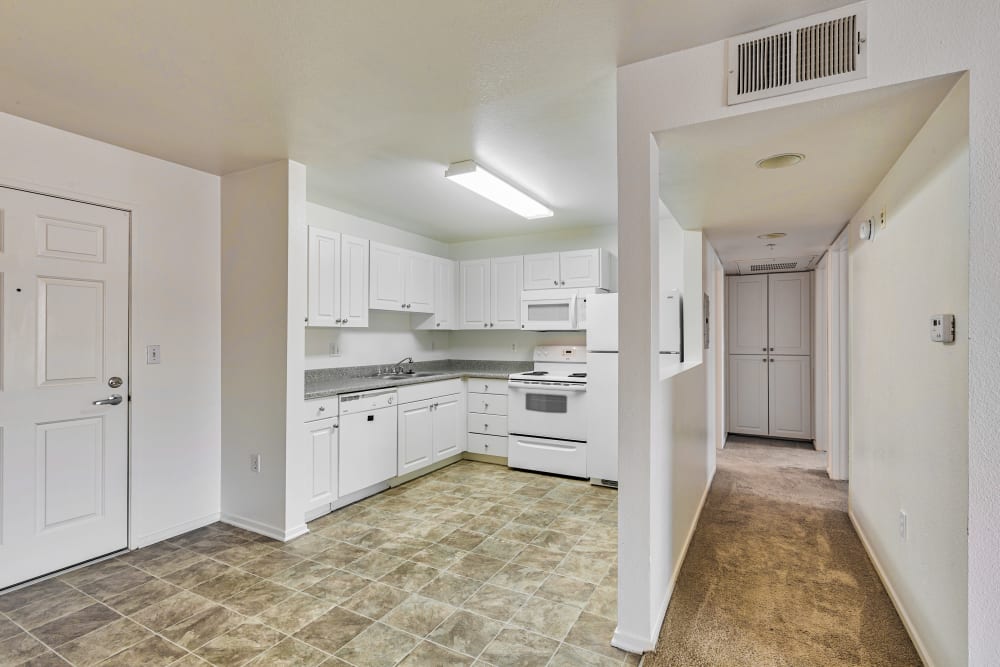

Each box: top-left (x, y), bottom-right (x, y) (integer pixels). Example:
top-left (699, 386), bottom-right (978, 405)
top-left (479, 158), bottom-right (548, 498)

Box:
top-left (587, 290), bottom-right (684, 486)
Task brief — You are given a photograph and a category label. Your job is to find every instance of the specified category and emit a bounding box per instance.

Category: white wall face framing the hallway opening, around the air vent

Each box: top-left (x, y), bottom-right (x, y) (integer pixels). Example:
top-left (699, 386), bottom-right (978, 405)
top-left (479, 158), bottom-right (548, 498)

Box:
top-left (618, 0), bottom-right (1000, 665)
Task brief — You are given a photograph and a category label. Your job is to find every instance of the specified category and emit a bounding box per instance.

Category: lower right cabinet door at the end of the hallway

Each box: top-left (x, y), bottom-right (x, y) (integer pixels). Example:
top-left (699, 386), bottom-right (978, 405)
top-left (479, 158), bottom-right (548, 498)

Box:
top-left (767, 356), bottom-right (813, 440)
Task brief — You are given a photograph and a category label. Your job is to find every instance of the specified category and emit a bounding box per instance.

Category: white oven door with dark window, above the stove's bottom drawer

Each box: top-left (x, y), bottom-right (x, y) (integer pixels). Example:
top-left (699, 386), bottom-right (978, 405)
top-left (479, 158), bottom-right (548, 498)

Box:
top-left (507, 380), bottom-right (587, 442)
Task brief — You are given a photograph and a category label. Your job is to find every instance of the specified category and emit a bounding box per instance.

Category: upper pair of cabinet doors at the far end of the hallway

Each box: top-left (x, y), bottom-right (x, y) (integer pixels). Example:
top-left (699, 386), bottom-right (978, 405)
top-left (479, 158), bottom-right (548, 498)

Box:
top-left (726, 273), bottom-right (812, 355)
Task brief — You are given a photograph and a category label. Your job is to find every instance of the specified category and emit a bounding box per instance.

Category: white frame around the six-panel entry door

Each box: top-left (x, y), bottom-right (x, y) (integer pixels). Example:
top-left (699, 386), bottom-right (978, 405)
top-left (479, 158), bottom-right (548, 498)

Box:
top-left (0, 176), bottom-right (138, 548)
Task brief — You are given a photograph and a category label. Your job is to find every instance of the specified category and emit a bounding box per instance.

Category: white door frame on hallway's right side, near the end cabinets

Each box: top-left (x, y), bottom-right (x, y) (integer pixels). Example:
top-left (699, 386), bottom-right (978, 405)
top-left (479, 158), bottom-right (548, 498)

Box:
top-left (826, 230), bottom-right (850, 480)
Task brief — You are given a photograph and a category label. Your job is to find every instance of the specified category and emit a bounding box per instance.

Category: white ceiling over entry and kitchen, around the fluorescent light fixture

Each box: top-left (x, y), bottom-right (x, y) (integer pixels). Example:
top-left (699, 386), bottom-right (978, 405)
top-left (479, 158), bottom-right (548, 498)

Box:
top-left (0, 0), bottom-right (856, 241)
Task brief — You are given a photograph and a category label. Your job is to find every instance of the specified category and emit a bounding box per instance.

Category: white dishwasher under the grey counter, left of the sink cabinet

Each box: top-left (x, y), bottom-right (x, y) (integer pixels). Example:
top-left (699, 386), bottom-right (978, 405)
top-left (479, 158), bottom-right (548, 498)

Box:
top-left (339, 389), bottom-right (397, 498)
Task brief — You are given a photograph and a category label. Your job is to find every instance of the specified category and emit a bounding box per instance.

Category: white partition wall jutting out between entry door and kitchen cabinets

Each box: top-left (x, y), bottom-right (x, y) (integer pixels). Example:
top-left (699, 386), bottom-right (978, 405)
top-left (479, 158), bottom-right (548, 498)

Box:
top-left (222, 160), bottom-right (306, 539)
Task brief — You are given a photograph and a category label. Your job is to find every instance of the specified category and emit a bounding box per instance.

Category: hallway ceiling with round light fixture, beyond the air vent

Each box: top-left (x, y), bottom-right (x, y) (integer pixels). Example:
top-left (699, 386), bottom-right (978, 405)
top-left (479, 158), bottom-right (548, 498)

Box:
top-left (656, 75), bottom-right (957, 272)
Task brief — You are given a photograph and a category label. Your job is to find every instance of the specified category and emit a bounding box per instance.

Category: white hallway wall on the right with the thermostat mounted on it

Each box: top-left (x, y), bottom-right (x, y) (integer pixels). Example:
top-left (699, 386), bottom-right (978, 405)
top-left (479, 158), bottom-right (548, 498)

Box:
top-left (848, 77), bottom-right (964, 665)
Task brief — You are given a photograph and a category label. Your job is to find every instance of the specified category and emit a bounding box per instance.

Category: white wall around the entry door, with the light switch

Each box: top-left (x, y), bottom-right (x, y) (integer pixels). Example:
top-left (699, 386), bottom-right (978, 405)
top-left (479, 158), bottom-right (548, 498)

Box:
top-left (0, 114), bottom-right (221, 547)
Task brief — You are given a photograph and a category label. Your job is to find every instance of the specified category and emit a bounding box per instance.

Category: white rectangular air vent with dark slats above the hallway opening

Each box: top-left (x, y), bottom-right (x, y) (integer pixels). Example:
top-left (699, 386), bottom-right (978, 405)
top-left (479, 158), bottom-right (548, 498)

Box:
top-left (728, 4), bottom-right (868, 105)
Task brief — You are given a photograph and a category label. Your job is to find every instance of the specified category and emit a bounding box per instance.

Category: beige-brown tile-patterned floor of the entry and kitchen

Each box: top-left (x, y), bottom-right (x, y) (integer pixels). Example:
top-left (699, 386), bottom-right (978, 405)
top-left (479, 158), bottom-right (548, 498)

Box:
top-left (0, 461), bottom-right (638, 667)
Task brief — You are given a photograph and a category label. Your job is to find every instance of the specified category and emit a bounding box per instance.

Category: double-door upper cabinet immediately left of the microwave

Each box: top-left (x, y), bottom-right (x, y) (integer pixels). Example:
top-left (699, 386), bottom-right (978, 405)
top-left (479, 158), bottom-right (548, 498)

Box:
top-left (459, 255), bottom-right (524, 329)
